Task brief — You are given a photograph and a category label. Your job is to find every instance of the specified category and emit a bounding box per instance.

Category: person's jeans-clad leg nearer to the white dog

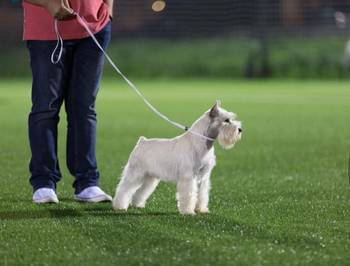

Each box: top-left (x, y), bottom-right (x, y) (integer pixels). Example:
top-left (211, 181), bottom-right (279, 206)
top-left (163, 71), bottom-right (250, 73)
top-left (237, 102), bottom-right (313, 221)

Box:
top-left (65, 21), bottom-right (111, 194)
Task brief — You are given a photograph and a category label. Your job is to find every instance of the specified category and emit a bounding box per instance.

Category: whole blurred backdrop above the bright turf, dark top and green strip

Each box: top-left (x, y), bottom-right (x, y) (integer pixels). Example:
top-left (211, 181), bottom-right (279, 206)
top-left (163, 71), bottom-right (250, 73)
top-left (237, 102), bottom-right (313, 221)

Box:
top-left (0, 0), bottom-right (350, 79)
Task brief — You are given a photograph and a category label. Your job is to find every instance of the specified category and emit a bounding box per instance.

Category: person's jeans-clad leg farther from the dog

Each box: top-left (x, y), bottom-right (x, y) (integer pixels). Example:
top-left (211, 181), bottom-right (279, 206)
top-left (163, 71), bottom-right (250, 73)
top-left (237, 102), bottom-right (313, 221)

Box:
top-left (27, 41), bottom-right (69, 191)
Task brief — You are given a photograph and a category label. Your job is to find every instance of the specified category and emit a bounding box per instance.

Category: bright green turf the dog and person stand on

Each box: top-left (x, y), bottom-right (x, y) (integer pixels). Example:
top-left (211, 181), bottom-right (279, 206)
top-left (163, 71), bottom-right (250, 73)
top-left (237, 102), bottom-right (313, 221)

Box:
top-left (0, 80), bottom-right (350, 265)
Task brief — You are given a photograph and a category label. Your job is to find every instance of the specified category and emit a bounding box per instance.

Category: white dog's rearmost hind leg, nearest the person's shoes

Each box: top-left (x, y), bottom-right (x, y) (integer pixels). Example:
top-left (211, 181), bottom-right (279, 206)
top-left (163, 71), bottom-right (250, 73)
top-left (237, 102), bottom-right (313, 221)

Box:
top-left (113, 165), bottom-right (144, 210)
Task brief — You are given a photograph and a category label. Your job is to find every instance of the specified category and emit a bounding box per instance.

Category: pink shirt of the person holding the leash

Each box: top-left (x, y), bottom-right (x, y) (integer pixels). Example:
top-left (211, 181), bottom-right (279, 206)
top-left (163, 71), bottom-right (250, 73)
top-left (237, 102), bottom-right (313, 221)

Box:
top-left (23, 0), bottom-right (109, 40)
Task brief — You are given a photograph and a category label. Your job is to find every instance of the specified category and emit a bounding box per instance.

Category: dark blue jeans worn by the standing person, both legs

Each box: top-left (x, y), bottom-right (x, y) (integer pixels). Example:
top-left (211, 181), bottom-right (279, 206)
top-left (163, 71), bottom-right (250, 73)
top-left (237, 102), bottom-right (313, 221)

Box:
top-left (27, 23), bottom-right (111, 194)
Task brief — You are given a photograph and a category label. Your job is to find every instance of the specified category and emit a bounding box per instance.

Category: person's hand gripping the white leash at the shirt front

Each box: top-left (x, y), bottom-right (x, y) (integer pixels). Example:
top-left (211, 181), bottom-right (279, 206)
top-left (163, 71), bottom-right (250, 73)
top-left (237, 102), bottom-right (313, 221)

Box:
top-left (43, 0), bottom-right (75, 20)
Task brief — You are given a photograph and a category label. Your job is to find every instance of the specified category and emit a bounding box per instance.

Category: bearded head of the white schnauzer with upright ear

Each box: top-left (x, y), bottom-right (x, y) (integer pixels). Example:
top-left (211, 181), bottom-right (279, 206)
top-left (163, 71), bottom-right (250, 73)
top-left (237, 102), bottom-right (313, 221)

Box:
top-left (207, 101), bottom-right (243, 149)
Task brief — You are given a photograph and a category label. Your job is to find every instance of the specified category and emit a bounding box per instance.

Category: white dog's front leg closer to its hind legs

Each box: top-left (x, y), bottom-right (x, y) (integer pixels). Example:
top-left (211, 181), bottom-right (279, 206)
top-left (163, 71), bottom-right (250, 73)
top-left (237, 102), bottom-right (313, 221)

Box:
top-left (177, 177), bottom-right (197, 215)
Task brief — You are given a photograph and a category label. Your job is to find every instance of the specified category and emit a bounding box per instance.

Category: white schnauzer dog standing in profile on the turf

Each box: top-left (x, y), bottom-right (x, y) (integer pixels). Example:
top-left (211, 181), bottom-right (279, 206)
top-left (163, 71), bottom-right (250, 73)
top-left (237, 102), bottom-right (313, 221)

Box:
top-left (113, 101), bottom-right (242, 215)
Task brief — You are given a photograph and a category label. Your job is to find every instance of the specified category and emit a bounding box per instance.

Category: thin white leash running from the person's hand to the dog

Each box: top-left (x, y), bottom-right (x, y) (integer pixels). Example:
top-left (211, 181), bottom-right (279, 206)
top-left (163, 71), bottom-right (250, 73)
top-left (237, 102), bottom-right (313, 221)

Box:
top-left (51, 13), bottom-right (215, 141)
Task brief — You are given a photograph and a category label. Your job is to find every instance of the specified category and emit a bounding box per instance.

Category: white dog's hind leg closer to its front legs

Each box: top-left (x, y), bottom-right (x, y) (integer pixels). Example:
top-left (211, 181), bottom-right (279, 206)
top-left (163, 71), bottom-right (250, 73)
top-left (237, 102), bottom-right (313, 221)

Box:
top-left (132, 177), bottom-right (159, 208)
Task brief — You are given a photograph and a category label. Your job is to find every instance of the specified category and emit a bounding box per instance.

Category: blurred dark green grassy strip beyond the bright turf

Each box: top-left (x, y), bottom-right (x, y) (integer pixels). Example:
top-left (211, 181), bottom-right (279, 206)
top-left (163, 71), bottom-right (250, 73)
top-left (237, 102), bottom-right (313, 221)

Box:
top-left (0, 36), bottom-right (350, 79)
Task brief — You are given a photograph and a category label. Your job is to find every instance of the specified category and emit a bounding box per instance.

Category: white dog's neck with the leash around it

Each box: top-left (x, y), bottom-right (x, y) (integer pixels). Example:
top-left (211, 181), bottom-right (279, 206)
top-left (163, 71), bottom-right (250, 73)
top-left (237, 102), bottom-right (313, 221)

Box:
top-left (186, 114), bottom-right (219, 153)
